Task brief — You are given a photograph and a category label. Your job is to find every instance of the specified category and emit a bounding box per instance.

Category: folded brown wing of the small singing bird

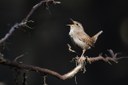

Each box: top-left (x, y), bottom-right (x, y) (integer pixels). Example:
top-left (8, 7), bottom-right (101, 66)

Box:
top-left (77, 32), bottom-right (94, 46)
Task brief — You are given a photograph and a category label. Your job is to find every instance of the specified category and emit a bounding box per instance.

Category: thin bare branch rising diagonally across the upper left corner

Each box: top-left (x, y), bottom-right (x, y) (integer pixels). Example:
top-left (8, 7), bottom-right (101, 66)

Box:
top-left (0, 0), bottom-right (60, 44)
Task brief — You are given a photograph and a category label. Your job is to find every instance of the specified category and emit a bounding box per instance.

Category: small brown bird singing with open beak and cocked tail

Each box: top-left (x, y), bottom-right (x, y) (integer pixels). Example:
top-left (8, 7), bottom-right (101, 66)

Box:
top-left (67, 19), bottom-right (103, 56)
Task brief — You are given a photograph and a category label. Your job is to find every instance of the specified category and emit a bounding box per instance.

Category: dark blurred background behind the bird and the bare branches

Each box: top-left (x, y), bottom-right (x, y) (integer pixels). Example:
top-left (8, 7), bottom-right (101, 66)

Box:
top-left (0, 0), bottom-right (128, 85)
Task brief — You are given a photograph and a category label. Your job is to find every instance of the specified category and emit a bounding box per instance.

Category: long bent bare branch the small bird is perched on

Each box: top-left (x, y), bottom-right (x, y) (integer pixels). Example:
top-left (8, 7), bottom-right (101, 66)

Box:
top-left (0, 50), bottom-right (119, 80)
